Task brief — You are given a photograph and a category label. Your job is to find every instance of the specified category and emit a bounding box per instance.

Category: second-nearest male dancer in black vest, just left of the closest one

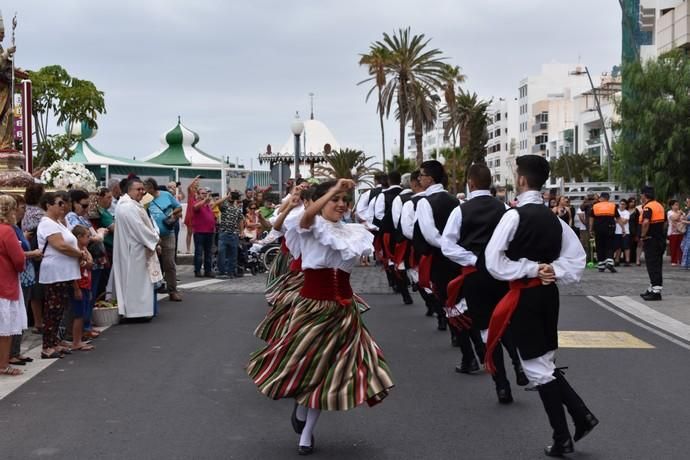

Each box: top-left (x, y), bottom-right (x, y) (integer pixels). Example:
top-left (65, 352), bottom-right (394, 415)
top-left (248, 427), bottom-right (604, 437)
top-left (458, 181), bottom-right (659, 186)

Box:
top-left (441, 164), bottom-right (529, 404)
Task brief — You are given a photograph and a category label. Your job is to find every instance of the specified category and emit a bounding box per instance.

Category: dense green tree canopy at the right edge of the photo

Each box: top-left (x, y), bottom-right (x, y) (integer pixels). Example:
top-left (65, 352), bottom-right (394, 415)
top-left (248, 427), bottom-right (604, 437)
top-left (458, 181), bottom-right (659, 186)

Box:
top-left (614, 50), bottom-right (690, 199)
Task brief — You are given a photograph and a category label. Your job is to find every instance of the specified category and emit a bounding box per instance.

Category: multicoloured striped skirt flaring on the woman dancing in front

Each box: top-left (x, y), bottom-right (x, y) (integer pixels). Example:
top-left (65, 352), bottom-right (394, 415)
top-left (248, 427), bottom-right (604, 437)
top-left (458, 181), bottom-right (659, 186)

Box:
top-left (247, 296), bottom-right (393, 410)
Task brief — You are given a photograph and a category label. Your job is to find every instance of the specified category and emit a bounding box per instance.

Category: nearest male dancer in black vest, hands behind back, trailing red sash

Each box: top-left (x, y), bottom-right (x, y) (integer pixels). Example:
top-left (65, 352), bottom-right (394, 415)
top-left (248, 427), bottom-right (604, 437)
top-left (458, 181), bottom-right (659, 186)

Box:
top-left (484, 155), bottom-right (599, 457)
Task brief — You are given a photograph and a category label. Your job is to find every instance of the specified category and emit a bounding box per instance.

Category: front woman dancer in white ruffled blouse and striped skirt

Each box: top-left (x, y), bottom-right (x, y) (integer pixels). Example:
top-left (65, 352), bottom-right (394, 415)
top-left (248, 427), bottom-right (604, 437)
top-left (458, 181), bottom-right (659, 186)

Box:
top-left (247, 179), bottom-right (393, 455)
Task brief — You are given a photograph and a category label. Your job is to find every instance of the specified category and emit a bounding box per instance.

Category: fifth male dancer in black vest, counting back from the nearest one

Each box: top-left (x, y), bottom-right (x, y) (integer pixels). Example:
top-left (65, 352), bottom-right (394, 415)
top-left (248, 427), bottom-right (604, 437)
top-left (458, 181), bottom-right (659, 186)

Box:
top-left (374, 171), bottom-right (412, 304)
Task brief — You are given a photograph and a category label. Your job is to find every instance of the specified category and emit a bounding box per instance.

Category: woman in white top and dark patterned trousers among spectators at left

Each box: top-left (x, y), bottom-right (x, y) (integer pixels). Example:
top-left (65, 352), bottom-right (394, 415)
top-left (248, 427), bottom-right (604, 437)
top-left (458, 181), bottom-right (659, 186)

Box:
top-left (37, 192), bottom-right (86, 359)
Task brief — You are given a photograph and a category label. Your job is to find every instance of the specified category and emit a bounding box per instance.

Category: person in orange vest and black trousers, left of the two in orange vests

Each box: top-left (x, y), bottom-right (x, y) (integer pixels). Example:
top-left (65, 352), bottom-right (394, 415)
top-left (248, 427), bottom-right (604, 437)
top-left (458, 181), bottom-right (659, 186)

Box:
top-left (589, 192), bottom-right (620, 273)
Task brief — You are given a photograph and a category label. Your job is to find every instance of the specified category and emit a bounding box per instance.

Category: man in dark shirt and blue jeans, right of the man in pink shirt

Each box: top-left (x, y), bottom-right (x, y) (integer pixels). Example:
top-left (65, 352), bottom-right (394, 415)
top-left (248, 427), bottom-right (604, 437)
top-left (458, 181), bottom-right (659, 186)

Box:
top-left (213, 192), bottom-right (244, 279)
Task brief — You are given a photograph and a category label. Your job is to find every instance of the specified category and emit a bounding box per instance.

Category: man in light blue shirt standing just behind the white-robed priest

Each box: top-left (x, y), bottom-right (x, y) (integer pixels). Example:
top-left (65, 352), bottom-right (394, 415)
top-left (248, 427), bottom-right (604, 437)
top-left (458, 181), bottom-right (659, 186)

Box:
top-left (144, 177), bottom-right (182, 302)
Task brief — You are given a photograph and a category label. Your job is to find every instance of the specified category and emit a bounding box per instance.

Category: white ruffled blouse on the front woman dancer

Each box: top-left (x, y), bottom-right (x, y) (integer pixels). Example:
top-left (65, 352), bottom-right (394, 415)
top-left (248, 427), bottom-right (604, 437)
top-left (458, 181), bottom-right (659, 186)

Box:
top-left (285, 216), bottom-right (374, 273)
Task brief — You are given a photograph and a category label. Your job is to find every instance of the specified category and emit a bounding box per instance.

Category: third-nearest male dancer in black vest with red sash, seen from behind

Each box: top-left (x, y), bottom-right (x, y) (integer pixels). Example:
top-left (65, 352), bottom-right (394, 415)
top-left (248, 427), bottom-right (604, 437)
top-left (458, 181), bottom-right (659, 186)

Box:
top-left (414, 160), bottom-right (456, 336)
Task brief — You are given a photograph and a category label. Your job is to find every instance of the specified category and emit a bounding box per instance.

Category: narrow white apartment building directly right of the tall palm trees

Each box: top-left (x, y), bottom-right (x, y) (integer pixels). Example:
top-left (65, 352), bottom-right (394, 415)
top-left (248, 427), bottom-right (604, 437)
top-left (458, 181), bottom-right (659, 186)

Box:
top-left (486, 98), bottom-right (518, 186)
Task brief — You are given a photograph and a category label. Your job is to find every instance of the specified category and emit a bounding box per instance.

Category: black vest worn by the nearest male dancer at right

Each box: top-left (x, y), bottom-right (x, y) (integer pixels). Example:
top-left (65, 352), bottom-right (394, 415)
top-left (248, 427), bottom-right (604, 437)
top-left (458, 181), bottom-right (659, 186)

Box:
top-left (506, 204), bottom-right (563, 264)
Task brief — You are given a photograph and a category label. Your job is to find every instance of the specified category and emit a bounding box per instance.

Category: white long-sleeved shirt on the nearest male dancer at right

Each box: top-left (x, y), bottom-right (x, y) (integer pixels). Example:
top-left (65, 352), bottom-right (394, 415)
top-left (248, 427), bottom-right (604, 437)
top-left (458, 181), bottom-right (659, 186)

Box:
top-left (484, 190), bottom-right (586, 283)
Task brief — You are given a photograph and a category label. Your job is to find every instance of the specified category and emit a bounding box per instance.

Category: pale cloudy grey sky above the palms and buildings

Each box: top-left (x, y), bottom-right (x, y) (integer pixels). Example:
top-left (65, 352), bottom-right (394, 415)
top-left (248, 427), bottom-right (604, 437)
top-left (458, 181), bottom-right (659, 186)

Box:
top-left (1, 0), bottom-right (621, 167)
